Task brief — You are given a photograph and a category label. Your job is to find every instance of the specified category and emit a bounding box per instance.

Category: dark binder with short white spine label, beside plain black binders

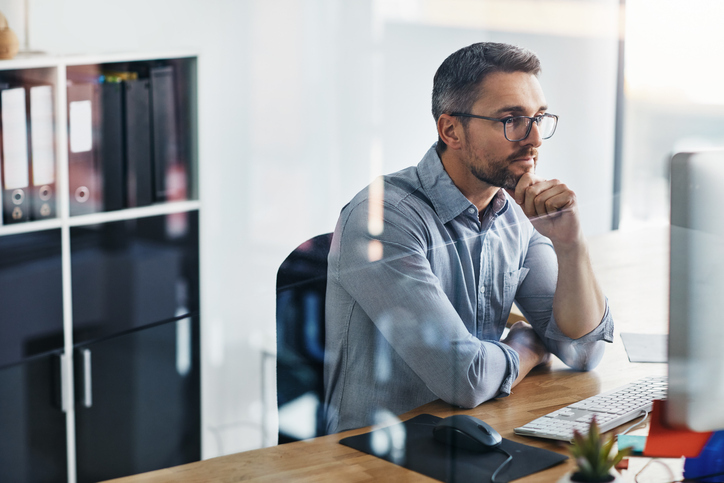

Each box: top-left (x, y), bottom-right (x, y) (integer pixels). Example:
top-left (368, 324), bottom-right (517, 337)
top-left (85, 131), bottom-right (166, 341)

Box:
top-left (68, 83), bottom-right (102, 216)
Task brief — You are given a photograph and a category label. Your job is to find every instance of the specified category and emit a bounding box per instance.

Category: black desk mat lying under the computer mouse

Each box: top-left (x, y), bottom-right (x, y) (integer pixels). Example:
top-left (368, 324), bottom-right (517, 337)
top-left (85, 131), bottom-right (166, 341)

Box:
top-left (340, 414), bottom-right (568, 483)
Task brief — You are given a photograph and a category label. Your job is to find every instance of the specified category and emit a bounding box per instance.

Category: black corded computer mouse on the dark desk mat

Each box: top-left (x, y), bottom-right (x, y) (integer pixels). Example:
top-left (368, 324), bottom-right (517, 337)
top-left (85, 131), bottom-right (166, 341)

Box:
top-left (432, 414), bottom-right (503, 452)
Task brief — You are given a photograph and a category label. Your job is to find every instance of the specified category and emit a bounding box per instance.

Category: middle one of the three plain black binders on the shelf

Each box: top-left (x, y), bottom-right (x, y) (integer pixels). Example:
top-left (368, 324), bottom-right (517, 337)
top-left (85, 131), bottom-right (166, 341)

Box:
top-left (124, 79), bottom-right (153, 207)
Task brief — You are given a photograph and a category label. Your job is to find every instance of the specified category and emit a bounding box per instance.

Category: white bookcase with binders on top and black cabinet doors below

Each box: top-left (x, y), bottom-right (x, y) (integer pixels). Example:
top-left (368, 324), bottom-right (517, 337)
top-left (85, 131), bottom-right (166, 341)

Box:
top-left (0, 52), bottom-right (201, 482)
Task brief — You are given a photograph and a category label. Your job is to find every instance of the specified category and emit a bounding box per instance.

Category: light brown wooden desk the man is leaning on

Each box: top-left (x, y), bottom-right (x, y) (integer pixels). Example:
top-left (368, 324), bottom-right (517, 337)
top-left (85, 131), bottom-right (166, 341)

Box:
top-left (106, 227), bottom-right (669, 483)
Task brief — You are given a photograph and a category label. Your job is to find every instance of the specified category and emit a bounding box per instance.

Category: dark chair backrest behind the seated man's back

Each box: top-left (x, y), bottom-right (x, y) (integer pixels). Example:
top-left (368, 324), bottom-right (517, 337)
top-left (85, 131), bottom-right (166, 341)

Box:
top-left (276, 233), bottom-right (332, 443)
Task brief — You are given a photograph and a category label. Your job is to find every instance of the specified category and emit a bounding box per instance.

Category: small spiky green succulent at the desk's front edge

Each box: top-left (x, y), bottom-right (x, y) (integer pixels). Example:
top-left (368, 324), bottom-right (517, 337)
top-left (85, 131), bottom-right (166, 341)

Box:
top-left (558, 418), bottom-right (631, 483)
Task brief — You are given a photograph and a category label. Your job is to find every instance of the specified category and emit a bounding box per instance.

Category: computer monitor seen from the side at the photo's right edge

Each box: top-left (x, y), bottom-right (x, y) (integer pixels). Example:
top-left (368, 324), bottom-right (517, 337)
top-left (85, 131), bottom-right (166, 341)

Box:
top-left (665, 149), bottom-right (724, 431)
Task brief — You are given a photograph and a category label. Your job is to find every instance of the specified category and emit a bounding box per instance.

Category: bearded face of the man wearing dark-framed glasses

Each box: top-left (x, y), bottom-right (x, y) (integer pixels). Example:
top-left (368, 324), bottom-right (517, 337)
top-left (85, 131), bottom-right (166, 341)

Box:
top-left (462, 72), bottom-right (547, 189)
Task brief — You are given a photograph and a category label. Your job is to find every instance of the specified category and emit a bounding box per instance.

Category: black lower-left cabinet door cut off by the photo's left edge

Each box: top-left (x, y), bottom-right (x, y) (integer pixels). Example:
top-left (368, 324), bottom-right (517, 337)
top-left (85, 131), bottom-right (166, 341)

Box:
top-left (0, 354), bottom-right (68, 483)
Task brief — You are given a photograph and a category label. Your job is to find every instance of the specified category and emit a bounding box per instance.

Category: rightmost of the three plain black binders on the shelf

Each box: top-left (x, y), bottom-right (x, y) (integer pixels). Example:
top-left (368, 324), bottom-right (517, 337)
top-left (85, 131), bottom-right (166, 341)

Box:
top-left (151, 66), bottom-right (179, 201)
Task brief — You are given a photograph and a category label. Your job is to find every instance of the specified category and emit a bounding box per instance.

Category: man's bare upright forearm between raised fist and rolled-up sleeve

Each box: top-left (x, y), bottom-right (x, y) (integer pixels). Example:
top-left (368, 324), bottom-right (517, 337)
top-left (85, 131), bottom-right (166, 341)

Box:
top-left (553, 238), bottom-right (606, 339)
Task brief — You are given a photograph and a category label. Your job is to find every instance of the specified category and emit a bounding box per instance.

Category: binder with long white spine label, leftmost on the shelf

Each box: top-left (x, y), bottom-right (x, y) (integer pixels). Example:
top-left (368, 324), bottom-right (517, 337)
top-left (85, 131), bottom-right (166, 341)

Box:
top-left (0, 87), bottom-right (30, 223)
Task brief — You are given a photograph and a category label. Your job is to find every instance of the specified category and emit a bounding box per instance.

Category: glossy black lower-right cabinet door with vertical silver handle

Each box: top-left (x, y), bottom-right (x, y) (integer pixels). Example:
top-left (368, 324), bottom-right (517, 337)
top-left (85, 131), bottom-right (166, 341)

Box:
top-left (75, 316), bottom-right (201, 483)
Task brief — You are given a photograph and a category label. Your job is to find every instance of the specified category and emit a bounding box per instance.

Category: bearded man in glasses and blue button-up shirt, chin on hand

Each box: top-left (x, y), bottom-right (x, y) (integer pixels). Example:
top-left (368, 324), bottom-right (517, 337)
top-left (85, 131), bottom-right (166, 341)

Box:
top-left (325, 43), bottom-right (613, 432)
